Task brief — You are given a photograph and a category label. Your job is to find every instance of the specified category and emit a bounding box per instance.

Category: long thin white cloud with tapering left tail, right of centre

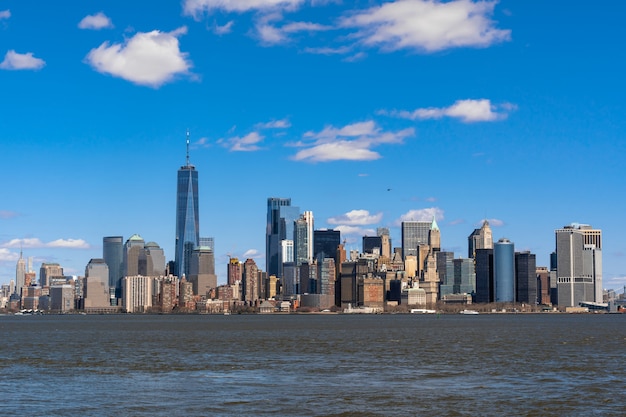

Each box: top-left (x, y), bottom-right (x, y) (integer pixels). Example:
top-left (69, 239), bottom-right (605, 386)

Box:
top-left (378, 99), bottom-right (516, 123)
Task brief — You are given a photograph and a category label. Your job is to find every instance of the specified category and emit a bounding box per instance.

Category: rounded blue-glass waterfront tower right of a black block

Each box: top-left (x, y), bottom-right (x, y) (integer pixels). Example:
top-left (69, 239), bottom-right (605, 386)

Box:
top-left (493, 238), bottom-right (515, 303)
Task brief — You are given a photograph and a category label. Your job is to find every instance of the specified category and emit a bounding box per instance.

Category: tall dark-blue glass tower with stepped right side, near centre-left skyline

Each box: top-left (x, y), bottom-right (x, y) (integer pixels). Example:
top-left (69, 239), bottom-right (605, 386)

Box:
top-left (265, 197), bottom-right (300, 277)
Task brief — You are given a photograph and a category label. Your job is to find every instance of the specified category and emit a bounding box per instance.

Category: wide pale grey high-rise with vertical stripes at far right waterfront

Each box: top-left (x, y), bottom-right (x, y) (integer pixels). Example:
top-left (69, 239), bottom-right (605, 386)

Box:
top-left (555, 223), bottom-right (602, 306)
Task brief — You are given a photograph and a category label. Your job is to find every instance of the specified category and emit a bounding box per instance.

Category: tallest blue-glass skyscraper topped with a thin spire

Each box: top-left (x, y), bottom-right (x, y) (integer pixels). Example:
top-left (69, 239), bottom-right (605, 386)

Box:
top-left (174, 131), bottom-right (200, 277)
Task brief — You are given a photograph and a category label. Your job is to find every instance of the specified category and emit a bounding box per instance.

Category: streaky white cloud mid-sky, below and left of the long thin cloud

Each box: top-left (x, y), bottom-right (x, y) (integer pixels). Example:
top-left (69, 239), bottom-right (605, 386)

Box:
top-left (292, 121), bottom-right (415, 162)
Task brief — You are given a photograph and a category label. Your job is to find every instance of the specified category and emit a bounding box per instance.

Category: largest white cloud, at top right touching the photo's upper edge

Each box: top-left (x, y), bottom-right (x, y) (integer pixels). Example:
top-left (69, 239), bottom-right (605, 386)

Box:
top-left (340, 0), bottom-right (511, 52)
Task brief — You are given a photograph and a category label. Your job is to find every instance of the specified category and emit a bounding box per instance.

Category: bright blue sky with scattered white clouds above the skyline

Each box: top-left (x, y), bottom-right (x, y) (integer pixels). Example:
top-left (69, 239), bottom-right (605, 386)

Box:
top-left (0, 0), bottom-right (626, 288)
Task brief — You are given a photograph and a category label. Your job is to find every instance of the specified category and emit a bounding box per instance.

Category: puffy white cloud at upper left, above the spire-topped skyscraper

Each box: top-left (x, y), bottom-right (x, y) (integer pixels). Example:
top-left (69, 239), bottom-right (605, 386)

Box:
top-left (86, 26), bottom-right (191, 88)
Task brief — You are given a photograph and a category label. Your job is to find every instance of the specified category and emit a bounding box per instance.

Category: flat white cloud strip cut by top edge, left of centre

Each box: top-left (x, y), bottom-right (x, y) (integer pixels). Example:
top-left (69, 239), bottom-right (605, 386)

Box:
top-left (183, 0), bottom-right (304, 18)
